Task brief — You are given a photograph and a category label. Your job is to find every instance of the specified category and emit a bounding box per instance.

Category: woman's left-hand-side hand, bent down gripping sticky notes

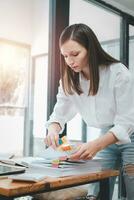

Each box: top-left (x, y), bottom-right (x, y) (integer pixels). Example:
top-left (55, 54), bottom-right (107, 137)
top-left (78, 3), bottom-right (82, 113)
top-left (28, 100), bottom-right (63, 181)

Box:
top-left (44, 122), bottom-right (61, 149)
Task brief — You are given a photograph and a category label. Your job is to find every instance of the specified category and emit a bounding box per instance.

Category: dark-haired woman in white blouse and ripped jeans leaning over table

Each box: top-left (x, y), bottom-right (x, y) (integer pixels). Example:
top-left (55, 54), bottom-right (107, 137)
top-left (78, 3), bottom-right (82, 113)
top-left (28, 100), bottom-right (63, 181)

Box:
top-left (45, 24), bottom-right (134, 200)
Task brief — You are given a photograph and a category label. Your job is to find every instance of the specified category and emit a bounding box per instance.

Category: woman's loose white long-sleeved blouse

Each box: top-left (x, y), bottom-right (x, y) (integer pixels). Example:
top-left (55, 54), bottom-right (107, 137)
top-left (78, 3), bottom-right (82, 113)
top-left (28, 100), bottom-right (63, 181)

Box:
top-left (46, 63), bottom-right (134, 144)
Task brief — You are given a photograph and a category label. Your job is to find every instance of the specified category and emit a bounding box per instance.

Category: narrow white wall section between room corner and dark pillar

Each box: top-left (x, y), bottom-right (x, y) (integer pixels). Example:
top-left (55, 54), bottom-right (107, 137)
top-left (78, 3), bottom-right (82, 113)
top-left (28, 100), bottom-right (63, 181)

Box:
top-left (32, 0), bottom-right (49, 55)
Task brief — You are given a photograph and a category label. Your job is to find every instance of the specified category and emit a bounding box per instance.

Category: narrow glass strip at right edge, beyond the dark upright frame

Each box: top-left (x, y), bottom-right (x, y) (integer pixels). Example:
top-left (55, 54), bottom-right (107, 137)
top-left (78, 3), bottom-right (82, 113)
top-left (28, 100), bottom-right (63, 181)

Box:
top-left (129, 25), bottom-right (134, 77)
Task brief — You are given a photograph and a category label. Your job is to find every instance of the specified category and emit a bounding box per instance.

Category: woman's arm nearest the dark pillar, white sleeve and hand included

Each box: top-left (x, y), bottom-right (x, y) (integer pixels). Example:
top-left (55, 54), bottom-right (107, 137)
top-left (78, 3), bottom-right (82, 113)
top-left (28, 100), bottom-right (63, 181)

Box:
top-left (45, 81), bottom-right (76, 148)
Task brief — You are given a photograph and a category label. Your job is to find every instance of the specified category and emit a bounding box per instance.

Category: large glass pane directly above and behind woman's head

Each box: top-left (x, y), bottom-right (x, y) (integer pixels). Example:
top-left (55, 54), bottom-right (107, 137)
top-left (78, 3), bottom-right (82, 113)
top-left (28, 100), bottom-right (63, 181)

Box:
top-left (70, 0), bottom-right (121, 58)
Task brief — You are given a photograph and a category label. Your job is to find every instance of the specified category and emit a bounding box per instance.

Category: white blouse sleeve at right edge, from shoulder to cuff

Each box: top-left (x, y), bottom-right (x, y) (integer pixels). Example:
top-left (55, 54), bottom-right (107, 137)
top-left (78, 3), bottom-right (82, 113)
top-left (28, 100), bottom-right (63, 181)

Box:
top-left (110, 65), bottom-right (134, 144)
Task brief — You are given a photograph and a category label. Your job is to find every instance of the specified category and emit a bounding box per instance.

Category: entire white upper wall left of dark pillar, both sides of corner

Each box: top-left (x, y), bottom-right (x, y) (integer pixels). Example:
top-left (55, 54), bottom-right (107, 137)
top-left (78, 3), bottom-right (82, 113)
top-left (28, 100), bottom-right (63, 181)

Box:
top-left (0, 0), bottom-right (49, 55)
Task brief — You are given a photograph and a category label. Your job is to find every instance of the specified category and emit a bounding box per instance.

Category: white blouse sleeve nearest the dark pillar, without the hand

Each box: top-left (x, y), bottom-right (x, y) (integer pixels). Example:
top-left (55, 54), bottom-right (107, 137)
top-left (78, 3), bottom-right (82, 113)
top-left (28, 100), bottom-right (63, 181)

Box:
top-left (45, 81), bottom-right (77, 132)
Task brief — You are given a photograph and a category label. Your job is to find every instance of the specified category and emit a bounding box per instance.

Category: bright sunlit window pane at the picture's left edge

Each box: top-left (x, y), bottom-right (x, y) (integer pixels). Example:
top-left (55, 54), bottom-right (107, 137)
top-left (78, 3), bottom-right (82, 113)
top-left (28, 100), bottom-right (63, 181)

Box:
top-left (0, 40), bottom-right (30, 155)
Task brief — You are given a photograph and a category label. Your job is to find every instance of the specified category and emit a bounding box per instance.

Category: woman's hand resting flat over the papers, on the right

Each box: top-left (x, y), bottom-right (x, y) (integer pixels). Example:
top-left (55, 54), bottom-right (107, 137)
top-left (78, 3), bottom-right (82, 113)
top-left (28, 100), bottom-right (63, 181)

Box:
top-left (69, 140), bottom-right (101, 160)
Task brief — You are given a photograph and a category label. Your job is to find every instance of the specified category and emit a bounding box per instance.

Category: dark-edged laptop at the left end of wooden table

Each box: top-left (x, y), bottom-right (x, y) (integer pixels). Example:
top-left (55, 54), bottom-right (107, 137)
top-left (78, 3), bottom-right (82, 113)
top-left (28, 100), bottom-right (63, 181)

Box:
top-left (0, 164), bottom-right (25, 176)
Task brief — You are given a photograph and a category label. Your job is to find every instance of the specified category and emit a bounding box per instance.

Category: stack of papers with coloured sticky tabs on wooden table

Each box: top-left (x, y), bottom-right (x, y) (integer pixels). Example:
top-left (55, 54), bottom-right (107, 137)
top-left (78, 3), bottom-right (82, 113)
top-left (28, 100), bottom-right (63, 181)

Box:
top-left (3, 147), bottom-right (107, 181)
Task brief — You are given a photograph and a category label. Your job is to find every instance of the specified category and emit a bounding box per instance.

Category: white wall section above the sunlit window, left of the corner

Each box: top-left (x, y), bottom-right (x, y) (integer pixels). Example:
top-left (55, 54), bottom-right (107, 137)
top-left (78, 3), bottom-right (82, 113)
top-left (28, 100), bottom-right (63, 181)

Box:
top-left (0, 0), bottom-right (32, 44)
